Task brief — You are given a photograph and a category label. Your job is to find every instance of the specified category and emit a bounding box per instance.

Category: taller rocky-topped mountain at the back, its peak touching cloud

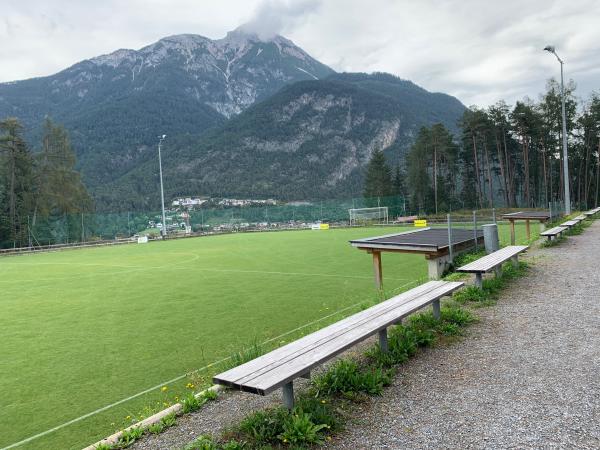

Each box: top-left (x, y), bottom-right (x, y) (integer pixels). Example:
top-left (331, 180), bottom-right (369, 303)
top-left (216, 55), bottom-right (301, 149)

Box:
top-left (0, 29), bottom-right (334, 187)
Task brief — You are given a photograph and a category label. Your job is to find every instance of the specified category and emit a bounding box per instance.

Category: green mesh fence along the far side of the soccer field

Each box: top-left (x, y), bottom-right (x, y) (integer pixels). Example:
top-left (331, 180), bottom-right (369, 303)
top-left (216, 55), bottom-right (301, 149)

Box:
top-left (4, 196), bottom-right (564, 248)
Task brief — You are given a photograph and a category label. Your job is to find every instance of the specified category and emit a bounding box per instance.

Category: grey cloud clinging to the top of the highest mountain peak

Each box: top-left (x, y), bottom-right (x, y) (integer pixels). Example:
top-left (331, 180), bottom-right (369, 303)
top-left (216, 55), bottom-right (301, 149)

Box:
top-left (240, 0), bottom-right (321, 39)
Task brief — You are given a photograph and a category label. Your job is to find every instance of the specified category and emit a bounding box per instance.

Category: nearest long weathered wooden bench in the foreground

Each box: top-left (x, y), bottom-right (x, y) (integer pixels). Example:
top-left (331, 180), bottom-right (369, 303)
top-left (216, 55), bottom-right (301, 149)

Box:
top-left (213, 281), bottom-right (464, 409)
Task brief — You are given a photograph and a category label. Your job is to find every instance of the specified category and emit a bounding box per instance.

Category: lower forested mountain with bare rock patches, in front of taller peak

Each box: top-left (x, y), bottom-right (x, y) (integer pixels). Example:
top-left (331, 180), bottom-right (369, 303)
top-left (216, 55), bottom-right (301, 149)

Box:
top-left (97, 73), bottom-right (465, 209)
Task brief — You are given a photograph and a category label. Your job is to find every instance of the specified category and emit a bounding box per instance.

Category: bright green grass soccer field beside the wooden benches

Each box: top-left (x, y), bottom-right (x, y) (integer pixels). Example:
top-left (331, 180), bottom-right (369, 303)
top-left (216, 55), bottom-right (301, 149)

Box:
top-left (0, 226), bottom-right (537, 449)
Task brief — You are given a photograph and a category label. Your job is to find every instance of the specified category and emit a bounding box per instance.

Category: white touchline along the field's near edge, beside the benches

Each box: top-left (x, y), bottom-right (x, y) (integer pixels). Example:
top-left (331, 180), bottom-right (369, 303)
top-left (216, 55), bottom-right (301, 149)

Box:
top-left (0, 281), bottom-right (415, 450)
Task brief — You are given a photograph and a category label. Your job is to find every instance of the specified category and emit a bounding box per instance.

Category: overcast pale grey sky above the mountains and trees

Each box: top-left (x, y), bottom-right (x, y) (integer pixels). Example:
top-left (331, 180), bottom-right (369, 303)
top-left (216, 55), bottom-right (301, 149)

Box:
top-left (0, 0), bottom-right (600, 106)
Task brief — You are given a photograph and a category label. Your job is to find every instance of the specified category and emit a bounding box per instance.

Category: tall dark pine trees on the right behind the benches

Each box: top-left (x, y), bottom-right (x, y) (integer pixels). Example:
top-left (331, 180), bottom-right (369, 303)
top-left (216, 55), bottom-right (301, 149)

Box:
top-left (364, 79), bottom-right (600, 213)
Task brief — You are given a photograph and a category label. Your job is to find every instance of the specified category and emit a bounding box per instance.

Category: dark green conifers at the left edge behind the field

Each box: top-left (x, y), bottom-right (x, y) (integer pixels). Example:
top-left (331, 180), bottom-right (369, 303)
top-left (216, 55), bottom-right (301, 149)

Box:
top-left (0, 118), bottom-right (93, 248)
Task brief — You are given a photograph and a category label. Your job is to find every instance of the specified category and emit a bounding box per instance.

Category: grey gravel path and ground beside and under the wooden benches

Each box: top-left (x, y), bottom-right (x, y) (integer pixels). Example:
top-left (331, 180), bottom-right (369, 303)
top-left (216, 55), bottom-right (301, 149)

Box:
top-left (131, 221), bottom-right (600, 450)
